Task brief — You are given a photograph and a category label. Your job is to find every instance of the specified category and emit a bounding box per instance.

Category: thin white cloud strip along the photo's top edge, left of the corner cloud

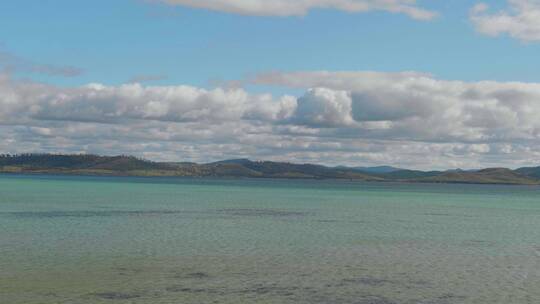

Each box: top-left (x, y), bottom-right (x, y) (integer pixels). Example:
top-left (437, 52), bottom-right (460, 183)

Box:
top-left (157, 0), bottom-right (436, 20)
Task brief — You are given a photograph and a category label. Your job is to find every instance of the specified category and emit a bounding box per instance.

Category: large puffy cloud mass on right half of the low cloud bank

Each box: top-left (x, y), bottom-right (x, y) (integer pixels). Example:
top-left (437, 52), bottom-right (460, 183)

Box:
top-left (253, 71), bottom-right (540, 142)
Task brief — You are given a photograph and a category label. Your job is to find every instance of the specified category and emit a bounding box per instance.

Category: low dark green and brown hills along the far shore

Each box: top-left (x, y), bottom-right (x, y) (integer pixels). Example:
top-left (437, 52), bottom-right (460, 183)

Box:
top-left (0, 154), bottom-right (540, 185)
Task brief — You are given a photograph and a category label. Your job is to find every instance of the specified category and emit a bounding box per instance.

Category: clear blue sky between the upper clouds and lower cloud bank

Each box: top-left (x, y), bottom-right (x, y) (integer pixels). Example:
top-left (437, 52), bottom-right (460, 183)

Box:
top-left (4, 0), bottom-right (540, 86)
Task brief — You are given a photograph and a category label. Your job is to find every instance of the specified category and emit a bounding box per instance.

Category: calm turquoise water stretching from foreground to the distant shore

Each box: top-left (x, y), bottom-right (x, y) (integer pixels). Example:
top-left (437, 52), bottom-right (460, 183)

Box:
top-left (0, 176), bottom-right (540, 304)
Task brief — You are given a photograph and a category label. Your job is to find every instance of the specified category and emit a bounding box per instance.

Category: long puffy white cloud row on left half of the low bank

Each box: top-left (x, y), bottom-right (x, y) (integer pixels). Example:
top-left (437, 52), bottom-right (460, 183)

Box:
top-left (0, 76), bottom-right (295, 123)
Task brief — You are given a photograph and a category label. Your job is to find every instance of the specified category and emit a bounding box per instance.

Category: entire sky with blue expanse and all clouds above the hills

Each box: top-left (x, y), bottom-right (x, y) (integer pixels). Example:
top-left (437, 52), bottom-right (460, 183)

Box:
top-left (0, 0), bottom-right (540, 169)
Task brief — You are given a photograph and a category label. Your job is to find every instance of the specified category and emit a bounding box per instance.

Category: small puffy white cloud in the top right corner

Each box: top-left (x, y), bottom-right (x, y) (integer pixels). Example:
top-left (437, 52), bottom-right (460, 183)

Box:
top-left (471, 0), bottom-right (540, 41)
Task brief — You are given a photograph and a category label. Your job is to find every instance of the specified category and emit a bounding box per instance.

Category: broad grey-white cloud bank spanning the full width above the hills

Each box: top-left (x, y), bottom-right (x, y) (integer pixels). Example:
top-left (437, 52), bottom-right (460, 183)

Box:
top-left (0, 71), bottom-right (540, 168)
